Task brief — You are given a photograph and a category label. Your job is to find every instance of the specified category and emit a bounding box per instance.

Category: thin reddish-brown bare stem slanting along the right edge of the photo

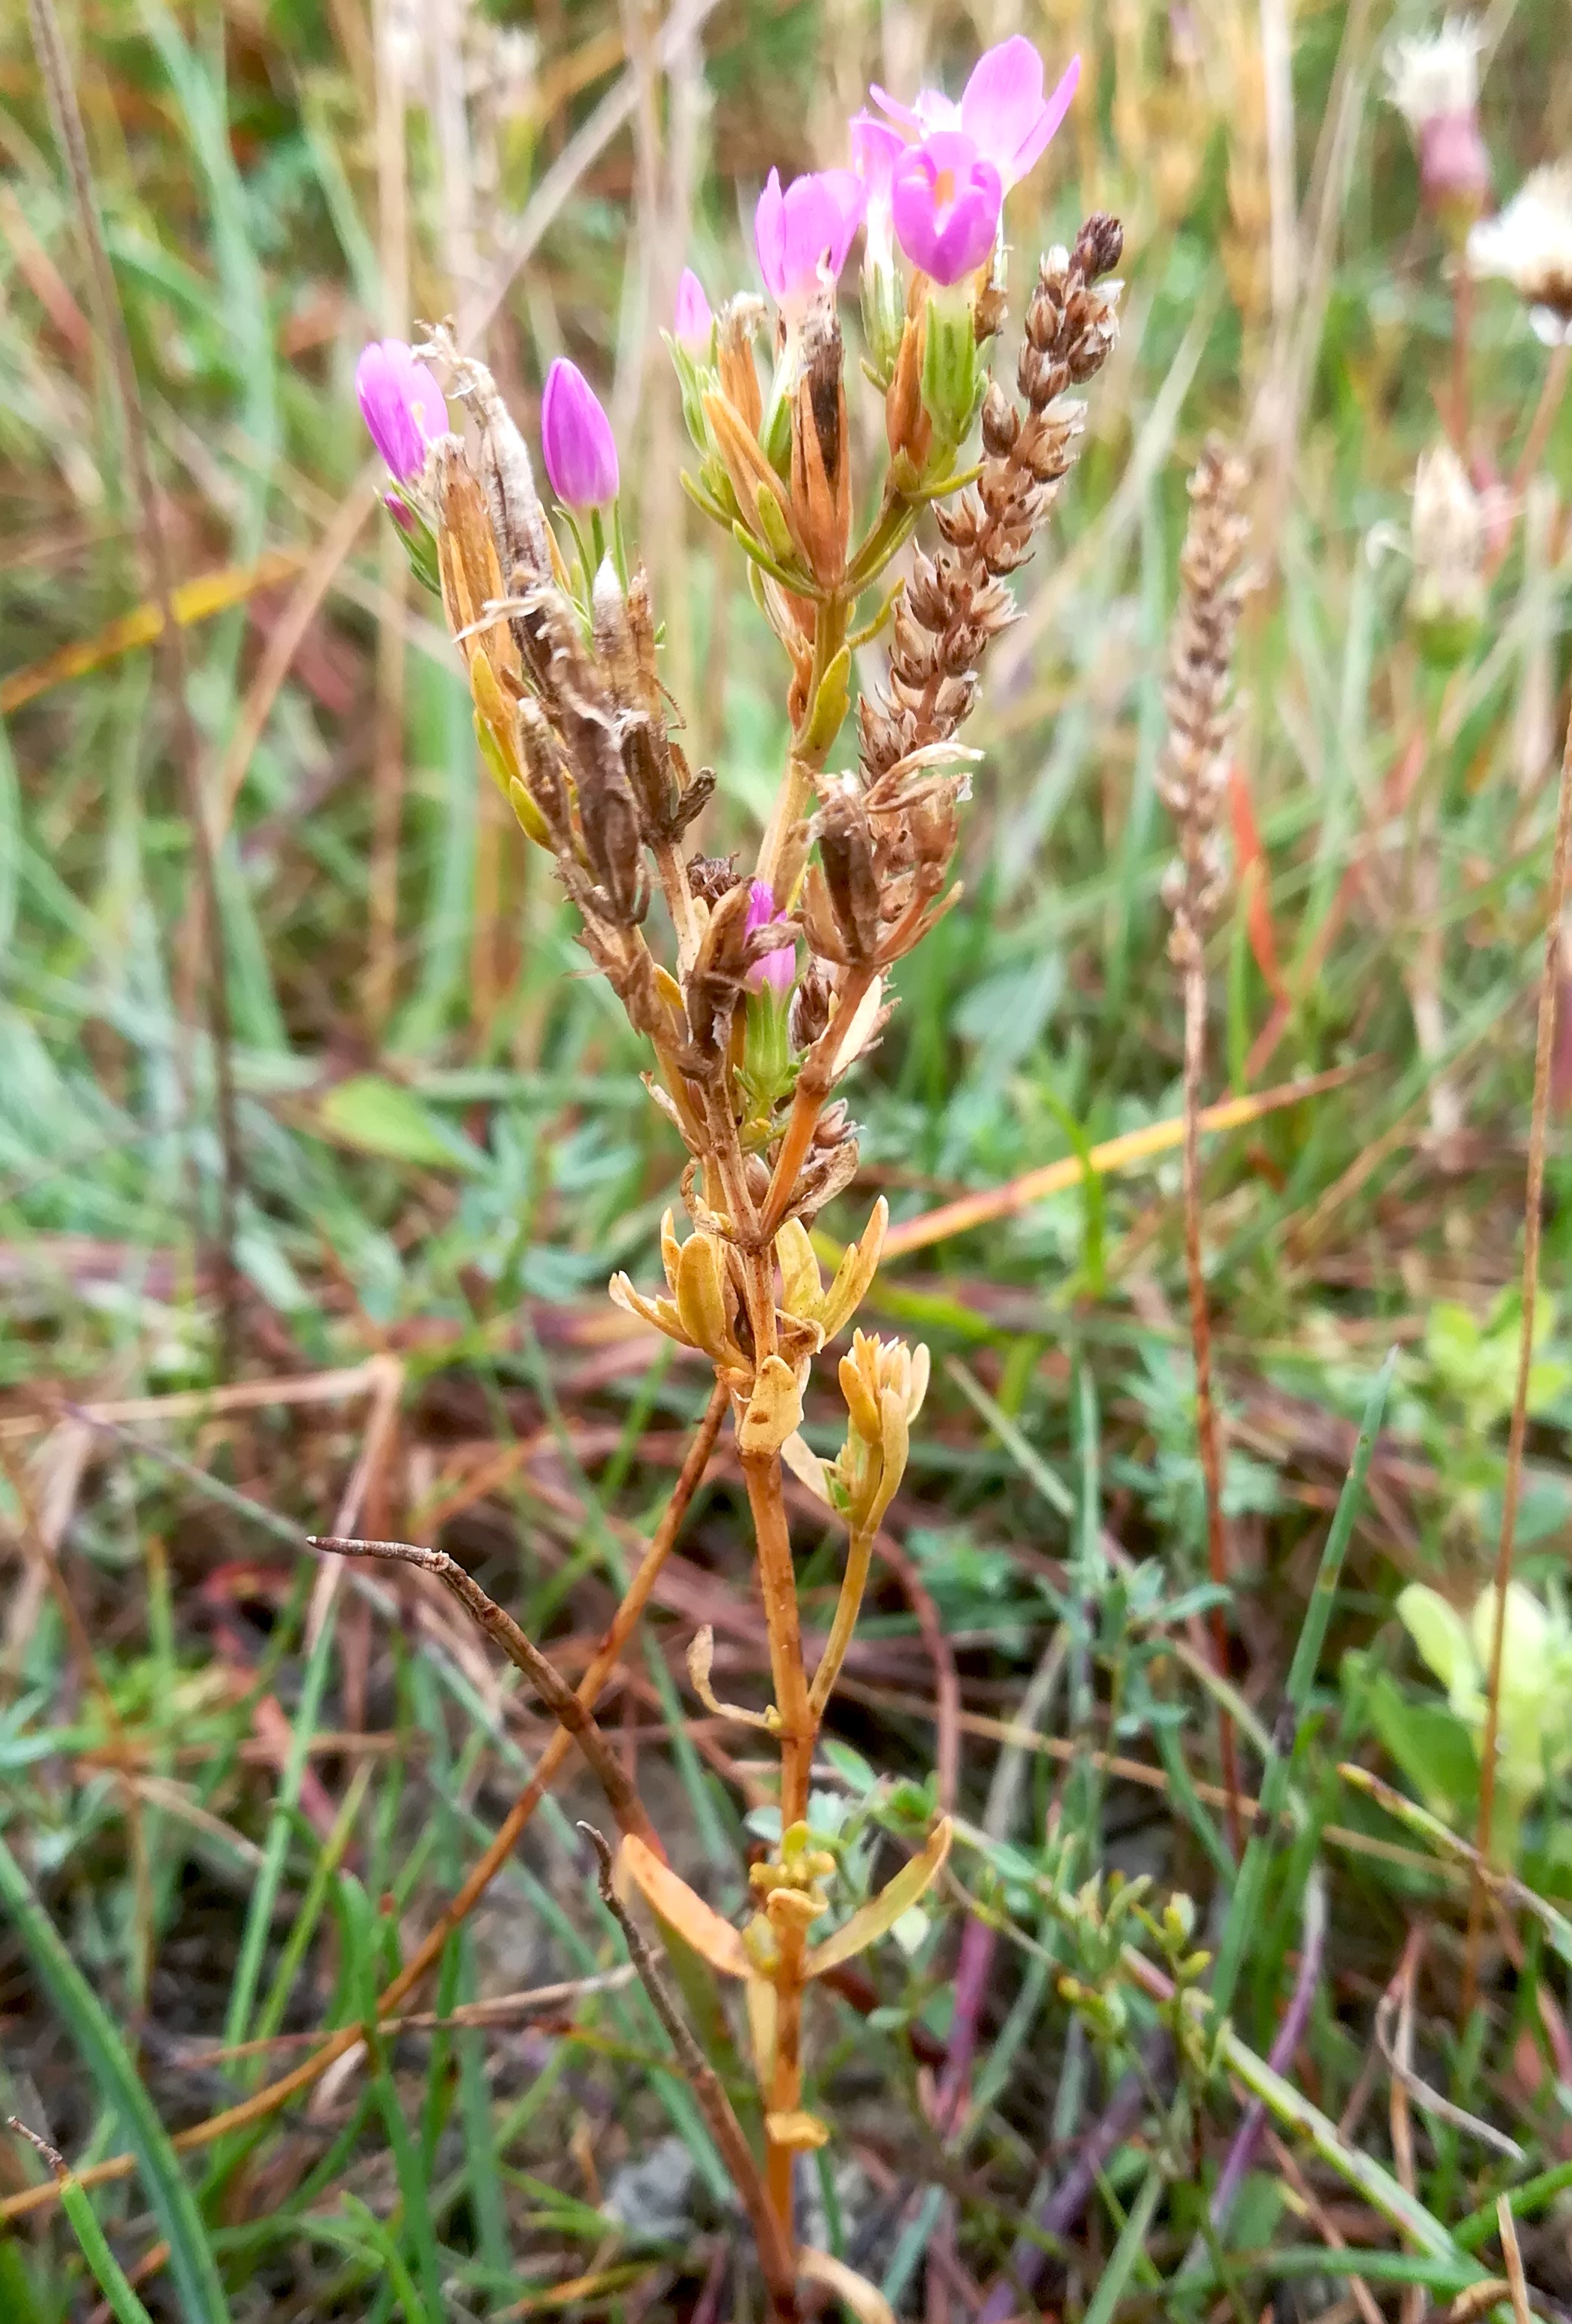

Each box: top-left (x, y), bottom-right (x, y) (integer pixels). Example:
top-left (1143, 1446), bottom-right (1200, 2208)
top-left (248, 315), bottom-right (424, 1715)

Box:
top-left (1463, 697), bottom-right (1572, 2022)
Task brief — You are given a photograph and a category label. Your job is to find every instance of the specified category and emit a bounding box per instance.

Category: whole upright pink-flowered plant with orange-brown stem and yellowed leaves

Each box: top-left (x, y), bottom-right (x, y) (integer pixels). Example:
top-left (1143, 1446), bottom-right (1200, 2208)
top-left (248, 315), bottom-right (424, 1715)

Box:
top-left (356, 39), bottom-right (1124, 2252)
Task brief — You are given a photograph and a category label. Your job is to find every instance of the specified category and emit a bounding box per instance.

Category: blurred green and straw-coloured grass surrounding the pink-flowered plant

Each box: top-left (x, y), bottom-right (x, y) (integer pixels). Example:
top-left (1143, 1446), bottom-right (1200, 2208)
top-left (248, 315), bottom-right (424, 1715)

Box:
top-left (0, 0), bottom-right (1572, 2324)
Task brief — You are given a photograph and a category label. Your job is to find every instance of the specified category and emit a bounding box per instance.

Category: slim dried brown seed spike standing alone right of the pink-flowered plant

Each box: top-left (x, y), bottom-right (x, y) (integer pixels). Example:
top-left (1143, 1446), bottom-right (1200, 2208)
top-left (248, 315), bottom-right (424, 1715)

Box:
top-left (1158, 437), bottom-right (1249, 964)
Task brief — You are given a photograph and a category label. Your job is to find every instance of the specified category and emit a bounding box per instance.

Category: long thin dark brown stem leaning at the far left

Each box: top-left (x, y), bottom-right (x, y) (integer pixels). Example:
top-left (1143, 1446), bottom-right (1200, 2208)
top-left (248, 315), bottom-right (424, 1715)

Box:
top-left (28, 0), bottom-right (242, 1376)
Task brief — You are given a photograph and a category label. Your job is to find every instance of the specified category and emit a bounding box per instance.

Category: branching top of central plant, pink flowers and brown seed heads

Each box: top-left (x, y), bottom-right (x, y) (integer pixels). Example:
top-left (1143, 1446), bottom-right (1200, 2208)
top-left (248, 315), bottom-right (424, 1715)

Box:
top-left (356, 23), bottom-right (1121, 1273)
